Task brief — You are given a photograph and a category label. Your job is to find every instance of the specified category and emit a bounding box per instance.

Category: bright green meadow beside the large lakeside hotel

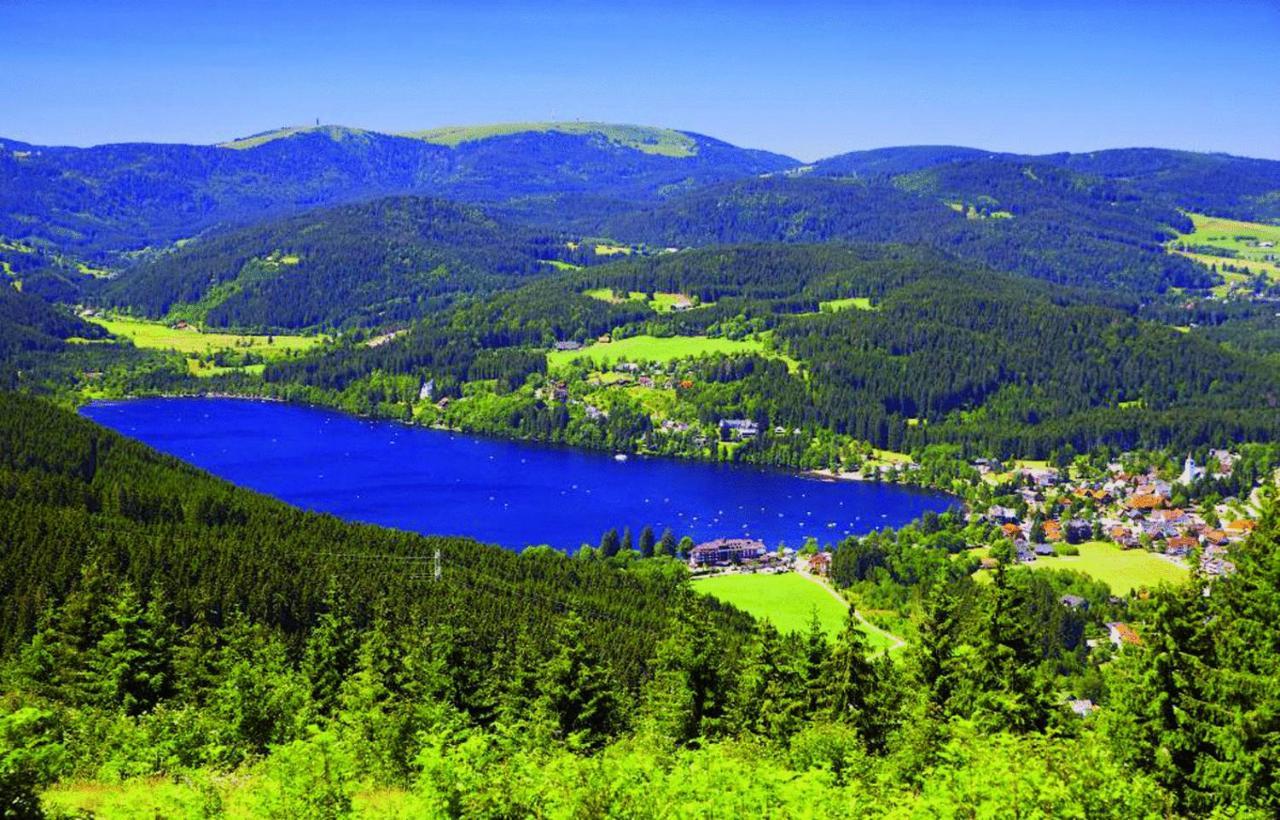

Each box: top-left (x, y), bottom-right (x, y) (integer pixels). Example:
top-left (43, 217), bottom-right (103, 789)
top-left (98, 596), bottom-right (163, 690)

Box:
top-left (694, 572), bottom-right (893, 650)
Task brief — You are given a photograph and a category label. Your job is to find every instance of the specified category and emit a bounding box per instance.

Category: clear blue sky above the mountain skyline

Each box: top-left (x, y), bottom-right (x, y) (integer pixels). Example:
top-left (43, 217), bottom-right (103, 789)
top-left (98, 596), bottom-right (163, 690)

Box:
top-left (0, 0), bottom-right (1280, 160)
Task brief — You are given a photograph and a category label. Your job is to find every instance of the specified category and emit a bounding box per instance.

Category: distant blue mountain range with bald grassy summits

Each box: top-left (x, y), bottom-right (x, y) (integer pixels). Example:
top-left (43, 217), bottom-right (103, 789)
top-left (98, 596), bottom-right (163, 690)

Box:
top-left (0, 125), bottom-right (796, 253)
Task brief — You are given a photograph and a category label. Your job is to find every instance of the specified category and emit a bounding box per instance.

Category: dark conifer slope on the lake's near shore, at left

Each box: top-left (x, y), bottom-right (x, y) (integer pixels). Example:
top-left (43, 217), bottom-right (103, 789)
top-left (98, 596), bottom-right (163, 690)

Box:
top-left (0, 391), bottom-right (742, 670)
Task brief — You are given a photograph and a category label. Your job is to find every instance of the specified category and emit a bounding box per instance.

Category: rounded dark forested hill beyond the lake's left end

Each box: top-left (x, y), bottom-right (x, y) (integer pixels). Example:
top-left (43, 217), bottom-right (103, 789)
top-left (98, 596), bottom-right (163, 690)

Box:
top-left (97, 197), bottom-right (570, 329)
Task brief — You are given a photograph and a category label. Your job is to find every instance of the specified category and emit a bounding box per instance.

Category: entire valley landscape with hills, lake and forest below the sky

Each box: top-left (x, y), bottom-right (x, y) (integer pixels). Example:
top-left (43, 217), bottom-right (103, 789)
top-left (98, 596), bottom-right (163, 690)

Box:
top-left (0, 111), bottom-right (1280, 817)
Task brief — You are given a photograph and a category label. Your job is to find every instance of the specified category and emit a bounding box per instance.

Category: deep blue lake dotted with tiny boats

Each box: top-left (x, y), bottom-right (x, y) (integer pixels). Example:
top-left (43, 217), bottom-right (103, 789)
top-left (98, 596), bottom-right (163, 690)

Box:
top-left (81, 398), bottom-right (955, 550)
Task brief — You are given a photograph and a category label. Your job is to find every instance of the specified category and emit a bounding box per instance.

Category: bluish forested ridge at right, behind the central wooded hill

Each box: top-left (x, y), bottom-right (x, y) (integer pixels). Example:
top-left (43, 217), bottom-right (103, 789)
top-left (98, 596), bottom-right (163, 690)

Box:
top-left (588, 171), bottom-right (1215, 294)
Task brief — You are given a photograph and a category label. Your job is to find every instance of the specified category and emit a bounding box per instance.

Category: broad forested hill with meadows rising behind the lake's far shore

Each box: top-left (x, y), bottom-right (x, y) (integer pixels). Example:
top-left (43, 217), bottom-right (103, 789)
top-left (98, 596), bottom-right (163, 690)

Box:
top-left (264, 243), bottom-right (1280, 457)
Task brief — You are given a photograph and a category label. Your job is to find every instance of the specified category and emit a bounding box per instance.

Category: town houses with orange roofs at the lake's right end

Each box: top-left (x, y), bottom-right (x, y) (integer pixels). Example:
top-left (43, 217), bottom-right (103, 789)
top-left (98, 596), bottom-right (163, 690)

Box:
top-left (975, 450), bottom-right (1254, 576)
